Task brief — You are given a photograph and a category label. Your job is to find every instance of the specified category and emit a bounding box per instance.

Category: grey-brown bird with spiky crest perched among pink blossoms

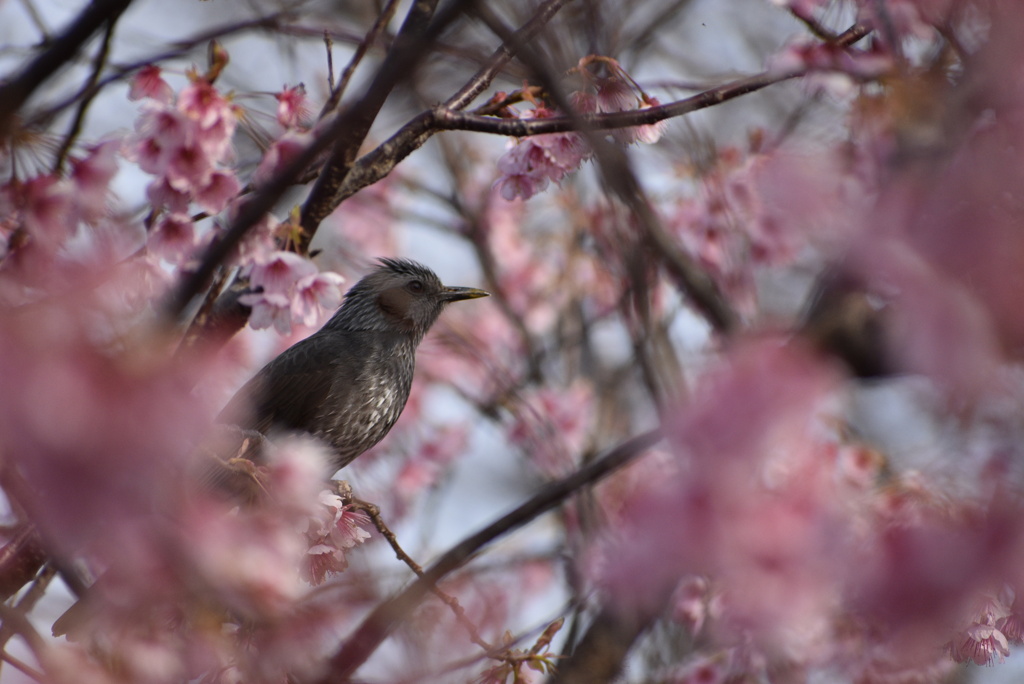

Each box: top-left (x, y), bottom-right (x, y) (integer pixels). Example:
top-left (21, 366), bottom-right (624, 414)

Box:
top-left (217, 258), bottom-right (489, 471)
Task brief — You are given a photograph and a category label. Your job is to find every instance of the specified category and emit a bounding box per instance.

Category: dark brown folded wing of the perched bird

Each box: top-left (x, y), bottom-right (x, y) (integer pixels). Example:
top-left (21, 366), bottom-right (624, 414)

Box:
top-left (218, 333), bottom-right (361, 434)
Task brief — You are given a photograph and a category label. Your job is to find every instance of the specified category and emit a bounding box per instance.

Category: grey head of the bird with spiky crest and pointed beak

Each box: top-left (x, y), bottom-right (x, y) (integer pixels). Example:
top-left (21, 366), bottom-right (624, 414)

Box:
top-left (326, 259), bottom-right (487, 341)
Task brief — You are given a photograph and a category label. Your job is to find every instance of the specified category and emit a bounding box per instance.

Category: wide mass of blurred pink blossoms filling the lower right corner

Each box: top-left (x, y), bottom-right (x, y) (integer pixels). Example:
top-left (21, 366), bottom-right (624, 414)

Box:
top-left (593, 340), bottom-right (1024, 682)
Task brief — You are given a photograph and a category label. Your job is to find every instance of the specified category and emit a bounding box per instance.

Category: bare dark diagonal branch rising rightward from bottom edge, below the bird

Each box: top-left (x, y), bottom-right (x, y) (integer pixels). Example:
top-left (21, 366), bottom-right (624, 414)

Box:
top-left (311, 430), bottom-right (662, 684)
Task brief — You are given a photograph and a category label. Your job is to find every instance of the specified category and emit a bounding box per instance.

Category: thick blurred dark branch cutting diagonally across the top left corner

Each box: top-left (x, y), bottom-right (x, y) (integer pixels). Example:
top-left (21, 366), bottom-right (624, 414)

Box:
top-left (0, 0), bottom-right (131, 139)
